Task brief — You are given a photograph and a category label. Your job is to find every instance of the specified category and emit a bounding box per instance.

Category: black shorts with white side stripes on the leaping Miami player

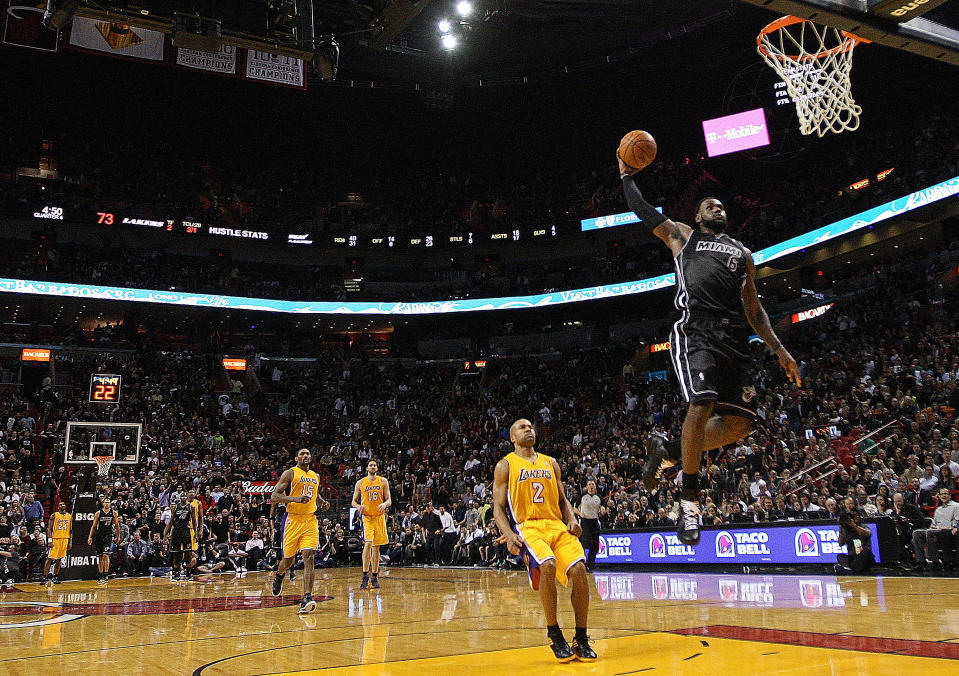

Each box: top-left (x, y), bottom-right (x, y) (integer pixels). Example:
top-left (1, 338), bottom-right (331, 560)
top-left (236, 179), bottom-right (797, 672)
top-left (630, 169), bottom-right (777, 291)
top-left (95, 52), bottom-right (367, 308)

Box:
top-left (669, 314), bottom-right (756, 417)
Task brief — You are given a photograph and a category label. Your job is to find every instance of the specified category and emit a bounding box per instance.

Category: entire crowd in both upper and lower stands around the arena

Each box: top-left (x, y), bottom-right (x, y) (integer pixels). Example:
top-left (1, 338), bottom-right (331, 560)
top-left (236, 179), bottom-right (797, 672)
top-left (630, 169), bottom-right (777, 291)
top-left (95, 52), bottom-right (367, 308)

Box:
top-left (0, 103), bottom-right (959, 578)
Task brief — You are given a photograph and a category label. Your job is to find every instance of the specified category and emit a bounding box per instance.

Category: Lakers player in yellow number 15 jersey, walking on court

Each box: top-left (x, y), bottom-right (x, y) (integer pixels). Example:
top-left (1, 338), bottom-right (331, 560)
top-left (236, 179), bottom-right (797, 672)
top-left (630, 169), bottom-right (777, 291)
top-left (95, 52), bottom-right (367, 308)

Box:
top-left (270, 448), bottom-right (330, 613)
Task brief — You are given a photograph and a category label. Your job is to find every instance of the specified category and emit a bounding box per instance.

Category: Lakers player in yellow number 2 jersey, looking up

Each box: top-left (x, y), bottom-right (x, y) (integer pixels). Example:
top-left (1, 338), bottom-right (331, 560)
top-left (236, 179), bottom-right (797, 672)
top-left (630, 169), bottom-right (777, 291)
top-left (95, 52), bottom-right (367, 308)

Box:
top-left (493, 418), bottom-right (596, 662)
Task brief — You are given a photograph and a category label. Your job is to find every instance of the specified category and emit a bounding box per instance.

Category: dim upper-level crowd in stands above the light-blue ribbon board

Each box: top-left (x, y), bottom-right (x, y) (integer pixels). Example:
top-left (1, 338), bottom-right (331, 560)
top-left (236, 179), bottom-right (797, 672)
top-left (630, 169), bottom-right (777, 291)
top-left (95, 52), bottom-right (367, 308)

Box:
top-left (0, 111), bottom-right (959, 300)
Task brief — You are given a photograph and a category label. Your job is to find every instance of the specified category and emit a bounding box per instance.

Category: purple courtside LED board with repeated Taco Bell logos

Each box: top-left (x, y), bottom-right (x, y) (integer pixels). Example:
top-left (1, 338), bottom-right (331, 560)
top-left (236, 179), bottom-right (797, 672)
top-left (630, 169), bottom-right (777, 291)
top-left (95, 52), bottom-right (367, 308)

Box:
top-left (596, 523), bottom-right (880, 564)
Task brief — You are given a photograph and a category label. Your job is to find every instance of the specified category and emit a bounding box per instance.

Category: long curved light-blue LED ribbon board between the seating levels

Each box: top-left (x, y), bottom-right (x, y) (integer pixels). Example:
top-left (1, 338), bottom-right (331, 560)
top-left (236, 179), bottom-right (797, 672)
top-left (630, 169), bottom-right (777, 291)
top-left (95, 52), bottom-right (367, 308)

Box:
top-left (0, 176), bottom-right (959, 315)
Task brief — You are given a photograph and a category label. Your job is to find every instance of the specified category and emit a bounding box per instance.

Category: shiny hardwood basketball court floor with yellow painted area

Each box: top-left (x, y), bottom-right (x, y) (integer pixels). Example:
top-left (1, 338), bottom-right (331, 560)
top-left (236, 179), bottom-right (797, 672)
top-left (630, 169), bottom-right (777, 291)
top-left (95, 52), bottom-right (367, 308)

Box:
top-left (0, 568), bottom-right (959, 676)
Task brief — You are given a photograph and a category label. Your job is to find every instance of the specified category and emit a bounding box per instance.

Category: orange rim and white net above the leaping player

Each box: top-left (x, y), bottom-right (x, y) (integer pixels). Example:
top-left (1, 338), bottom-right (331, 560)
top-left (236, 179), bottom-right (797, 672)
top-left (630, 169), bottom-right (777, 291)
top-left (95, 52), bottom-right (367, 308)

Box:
top-left (756, 16), bottom-right (869, 137)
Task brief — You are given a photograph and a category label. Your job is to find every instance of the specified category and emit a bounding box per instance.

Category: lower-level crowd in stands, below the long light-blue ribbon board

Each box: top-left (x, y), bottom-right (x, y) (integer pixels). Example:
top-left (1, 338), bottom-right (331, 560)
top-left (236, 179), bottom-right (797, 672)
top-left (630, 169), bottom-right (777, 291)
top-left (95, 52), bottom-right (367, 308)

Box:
top-left (0, 234), bottom-right (959, 578)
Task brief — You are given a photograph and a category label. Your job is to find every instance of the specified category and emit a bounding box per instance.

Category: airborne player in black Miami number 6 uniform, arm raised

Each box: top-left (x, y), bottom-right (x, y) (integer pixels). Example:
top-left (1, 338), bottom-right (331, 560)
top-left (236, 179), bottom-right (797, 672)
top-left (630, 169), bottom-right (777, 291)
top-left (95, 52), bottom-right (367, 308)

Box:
top-left (617, 156), bottom-right (801, 545)
